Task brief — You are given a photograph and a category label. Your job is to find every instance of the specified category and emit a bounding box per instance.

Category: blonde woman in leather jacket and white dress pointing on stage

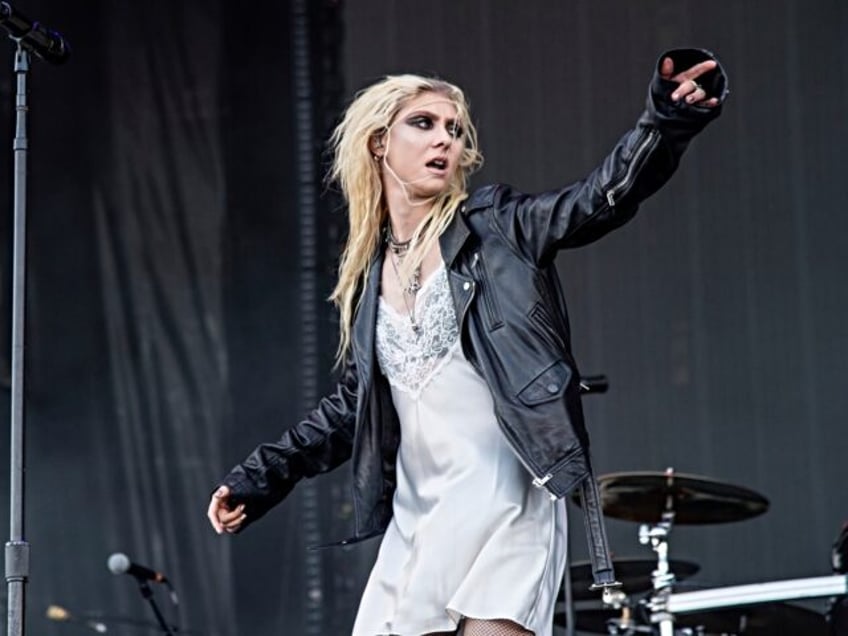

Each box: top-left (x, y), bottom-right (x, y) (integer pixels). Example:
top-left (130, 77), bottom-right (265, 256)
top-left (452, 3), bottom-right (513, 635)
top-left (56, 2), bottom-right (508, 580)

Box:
top-left (208, 50), bottom-right (727, 636)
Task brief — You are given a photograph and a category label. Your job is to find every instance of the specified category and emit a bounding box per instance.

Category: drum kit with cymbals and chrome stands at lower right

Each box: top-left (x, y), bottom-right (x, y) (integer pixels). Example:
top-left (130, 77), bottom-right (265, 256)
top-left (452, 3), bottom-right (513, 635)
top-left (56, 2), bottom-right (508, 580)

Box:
top-left (555, 468), bottom-right (848, 636)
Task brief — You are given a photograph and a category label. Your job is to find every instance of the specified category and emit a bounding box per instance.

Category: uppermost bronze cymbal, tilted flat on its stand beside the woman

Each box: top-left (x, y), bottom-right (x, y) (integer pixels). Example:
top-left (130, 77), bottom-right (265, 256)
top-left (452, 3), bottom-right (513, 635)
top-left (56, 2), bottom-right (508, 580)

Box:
top-left (575, 471), bottom-right (769, 524)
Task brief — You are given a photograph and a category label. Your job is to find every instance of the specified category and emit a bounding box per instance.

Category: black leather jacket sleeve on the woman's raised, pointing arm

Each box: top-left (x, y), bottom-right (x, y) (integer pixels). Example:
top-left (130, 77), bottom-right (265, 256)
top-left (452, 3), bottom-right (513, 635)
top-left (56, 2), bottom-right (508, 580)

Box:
top-left (494, 49), bottom-right (728, 265)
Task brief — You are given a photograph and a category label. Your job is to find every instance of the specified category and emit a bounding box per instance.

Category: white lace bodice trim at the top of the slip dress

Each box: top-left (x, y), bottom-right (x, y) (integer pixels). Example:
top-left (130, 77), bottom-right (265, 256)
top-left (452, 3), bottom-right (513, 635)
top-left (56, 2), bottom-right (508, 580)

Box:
top-left (377, 263), bottom-right (459, 399)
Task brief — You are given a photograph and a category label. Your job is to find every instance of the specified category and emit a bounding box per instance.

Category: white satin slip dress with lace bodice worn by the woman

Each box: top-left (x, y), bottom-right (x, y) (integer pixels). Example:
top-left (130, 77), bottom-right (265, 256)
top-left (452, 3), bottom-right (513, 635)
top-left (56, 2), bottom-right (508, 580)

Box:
top-left (353, 264), bottom-right (566, 636)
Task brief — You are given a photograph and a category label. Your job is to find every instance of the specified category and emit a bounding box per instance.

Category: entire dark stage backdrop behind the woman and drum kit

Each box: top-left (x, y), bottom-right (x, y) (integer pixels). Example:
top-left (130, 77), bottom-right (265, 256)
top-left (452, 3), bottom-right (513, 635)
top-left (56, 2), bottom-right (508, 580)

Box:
top-left (0, 0), bottom-right (848, 636)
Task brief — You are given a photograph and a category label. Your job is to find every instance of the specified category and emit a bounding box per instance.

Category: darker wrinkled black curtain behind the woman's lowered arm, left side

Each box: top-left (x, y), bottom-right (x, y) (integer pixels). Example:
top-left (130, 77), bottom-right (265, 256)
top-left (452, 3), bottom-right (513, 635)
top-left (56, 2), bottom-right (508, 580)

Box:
top-left (0, 0), bottom-right (346, 636)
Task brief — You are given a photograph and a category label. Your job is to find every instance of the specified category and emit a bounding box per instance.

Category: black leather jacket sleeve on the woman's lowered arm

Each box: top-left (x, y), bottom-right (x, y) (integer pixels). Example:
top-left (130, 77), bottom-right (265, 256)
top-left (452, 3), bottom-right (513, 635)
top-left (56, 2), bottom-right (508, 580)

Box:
top-left (221, 356), bottom-right (357, 529)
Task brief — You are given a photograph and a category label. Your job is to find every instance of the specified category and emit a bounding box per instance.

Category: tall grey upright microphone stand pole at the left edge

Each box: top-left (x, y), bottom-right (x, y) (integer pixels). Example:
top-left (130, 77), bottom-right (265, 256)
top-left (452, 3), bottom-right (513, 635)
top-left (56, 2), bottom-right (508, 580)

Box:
top-left (6, 40), bottom-right (30, 636)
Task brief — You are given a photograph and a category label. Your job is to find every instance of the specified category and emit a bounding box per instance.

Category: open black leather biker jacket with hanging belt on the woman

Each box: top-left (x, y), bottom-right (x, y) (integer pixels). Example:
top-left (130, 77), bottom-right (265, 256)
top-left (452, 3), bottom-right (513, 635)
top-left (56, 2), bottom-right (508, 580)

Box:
top-left (222, 49), bottom-right (727, 585)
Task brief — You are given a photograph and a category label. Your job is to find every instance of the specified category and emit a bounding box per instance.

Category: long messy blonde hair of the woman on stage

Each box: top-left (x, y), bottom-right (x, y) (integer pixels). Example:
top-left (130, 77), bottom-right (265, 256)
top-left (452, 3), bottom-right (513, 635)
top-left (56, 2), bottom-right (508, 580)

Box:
top-left (327, 75), bottom-right (483, 363)
